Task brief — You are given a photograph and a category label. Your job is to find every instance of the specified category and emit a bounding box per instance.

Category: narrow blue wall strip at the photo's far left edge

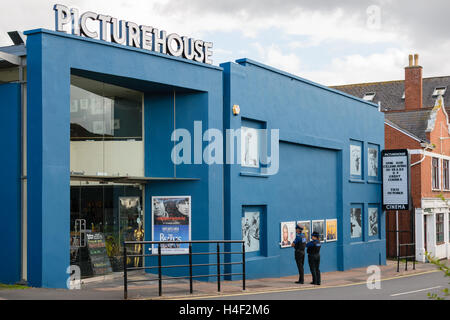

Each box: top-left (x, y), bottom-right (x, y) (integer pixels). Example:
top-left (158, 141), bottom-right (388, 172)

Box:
top-left (0, 83), bottom-right (21, 284)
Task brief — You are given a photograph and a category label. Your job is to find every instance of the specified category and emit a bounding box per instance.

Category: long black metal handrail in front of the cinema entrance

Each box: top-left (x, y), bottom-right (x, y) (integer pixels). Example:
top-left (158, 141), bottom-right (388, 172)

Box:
top-left (123, 240), bottom-right (245, 299)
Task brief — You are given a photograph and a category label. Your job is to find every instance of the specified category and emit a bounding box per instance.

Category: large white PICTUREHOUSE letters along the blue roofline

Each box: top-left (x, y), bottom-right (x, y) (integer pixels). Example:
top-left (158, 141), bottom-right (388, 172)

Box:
top-left (53, 4), bottom-right (213, 64)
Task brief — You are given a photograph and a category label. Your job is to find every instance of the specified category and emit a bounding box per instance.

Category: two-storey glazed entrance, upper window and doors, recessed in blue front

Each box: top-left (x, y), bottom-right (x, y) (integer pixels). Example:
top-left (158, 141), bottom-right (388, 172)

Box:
top-left (70, 75), bottom-right (145, 278)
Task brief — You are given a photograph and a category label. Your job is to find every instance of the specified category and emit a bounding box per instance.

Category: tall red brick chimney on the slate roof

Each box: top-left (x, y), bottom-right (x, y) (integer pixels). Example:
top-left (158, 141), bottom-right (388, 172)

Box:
top-left (405, 53), bottom-right (422, 110)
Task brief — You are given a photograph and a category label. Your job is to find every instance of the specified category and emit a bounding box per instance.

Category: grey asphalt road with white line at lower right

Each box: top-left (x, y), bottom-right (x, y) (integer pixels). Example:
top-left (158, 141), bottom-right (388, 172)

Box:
top-left (202, 272), bottom-right (450, 300)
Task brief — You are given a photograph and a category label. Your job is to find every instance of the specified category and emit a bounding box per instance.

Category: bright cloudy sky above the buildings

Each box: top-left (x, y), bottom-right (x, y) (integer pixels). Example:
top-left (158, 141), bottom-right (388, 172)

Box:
top-left (0, 0), bottom-right (450, 86)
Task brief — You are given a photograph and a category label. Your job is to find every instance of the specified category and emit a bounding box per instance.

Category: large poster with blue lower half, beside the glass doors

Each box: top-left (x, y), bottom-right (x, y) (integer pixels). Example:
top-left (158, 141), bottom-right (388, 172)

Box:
top-left (152, 196), bottom-right (191, 254)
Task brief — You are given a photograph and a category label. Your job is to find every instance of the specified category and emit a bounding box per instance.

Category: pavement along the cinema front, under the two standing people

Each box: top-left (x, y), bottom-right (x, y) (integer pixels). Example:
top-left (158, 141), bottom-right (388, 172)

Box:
top-left (0, 260), bottom-right (437, 300)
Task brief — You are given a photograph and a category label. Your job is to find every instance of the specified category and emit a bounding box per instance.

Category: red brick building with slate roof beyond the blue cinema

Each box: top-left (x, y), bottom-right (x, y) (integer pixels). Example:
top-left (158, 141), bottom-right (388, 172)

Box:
top-left (333, 55), bottom-right (450, 261)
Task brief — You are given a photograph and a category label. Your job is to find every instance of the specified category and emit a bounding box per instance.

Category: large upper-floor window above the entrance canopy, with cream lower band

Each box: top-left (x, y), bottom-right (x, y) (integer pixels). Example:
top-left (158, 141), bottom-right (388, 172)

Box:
top-left (70, 75), bottom-right (145, 176)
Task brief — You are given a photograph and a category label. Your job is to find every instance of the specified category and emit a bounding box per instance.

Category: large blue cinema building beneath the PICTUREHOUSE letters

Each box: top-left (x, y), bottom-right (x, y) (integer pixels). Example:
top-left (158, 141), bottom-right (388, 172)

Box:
top-left (0, 29), bottom-right (386, 288)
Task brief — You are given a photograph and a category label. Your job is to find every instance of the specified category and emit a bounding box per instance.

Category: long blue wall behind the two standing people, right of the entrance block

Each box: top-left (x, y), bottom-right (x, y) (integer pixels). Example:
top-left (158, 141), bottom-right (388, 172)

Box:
top-left (221, 59), bottom-right (385, 278)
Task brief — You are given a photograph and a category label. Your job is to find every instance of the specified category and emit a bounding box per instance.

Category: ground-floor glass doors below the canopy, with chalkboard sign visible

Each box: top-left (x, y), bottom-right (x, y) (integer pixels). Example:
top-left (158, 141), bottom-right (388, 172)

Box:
top-left (70, 182), bottom-right (144, 278)
